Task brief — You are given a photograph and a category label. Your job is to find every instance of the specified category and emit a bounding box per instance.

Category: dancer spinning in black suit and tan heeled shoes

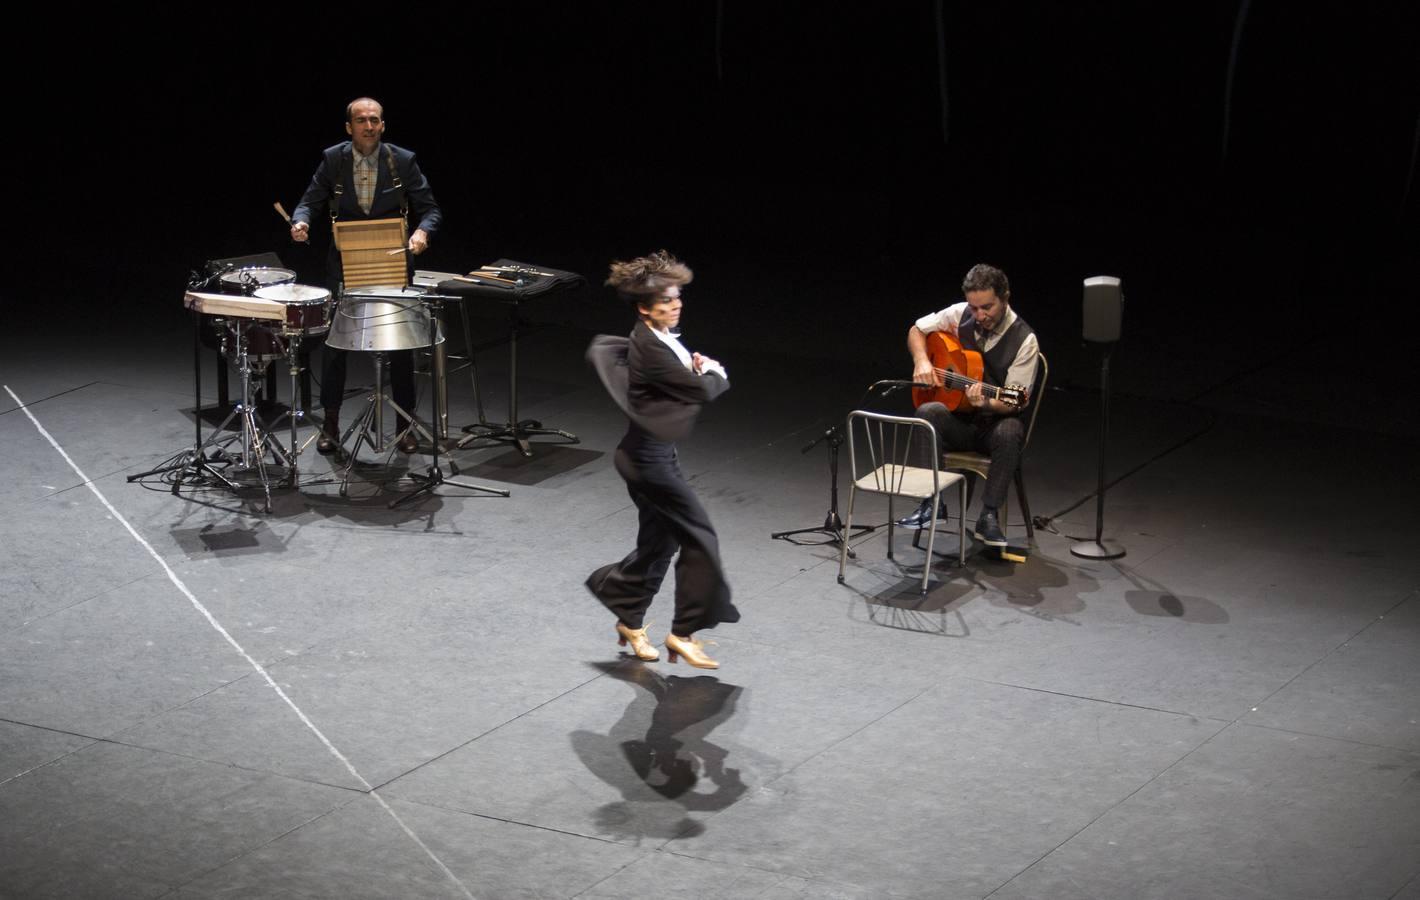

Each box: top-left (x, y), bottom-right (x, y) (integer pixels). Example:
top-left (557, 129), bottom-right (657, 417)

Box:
top-left (586, 250), bottom-right (740, 669)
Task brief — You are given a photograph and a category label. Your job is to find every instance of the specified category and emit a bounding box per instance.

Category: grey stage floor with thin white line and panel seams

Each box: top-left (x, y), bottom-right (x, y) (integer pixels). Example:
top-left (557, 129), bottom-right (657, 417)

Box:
top-left (0, 312), bottom-right (1420, 900)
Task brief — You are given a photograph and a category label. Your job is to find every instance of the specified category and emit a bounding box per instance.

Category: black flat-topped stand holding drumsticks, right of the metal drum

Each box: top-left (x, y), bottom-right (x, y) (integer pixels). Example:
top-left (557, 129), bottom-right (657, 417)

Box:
top-left (437, 260), bottom-right (586, 456)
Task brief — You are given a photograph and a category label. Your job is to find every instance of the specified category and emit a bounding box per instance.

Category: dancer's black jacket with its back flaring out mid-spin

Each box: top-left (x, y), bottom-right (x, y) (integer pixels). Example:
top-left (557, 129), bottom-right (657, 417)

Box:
top-left (586, 322), bottom-right (730, 443)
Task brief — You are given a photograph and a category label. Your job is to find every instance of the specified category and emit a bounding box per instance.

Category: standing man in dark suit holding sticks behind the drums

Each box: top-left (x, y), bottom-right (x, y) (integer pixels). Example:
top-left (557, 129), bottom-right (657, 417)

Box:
top-left (291, 97), bottom-right (443, 453)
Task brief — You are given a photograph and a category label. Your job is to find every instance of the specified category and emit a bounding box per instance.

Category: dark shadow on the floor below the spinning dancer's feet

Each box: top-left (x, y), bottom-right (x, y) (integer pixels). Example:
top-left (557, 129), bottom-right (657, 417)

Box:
top-left (571, 662), bottom-right (747, 839)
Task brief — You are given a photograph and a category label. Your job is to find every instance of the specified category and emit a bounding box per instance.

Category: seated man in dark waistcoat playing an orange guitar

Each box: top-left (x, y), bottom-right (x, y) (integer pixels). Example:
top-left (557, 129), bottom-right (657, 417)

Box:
top-left (897, 263), bottom-right (1039, 547)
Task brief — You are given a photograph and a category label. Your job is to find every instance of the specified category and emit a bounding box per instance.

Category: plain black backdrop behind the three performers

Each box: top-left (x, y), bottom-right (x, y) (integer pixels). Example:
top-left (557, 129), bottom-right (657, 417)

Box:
top-left (13, 0), bottom-right (1420, 369)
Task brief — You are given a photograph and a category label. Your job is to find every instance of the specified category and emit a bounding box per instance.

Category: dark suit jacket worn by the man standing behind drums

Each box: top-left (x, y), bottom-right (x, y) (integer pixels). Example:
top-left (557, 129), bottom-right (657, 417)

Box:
top-left (291, 141), bottom-right (443, 284)
